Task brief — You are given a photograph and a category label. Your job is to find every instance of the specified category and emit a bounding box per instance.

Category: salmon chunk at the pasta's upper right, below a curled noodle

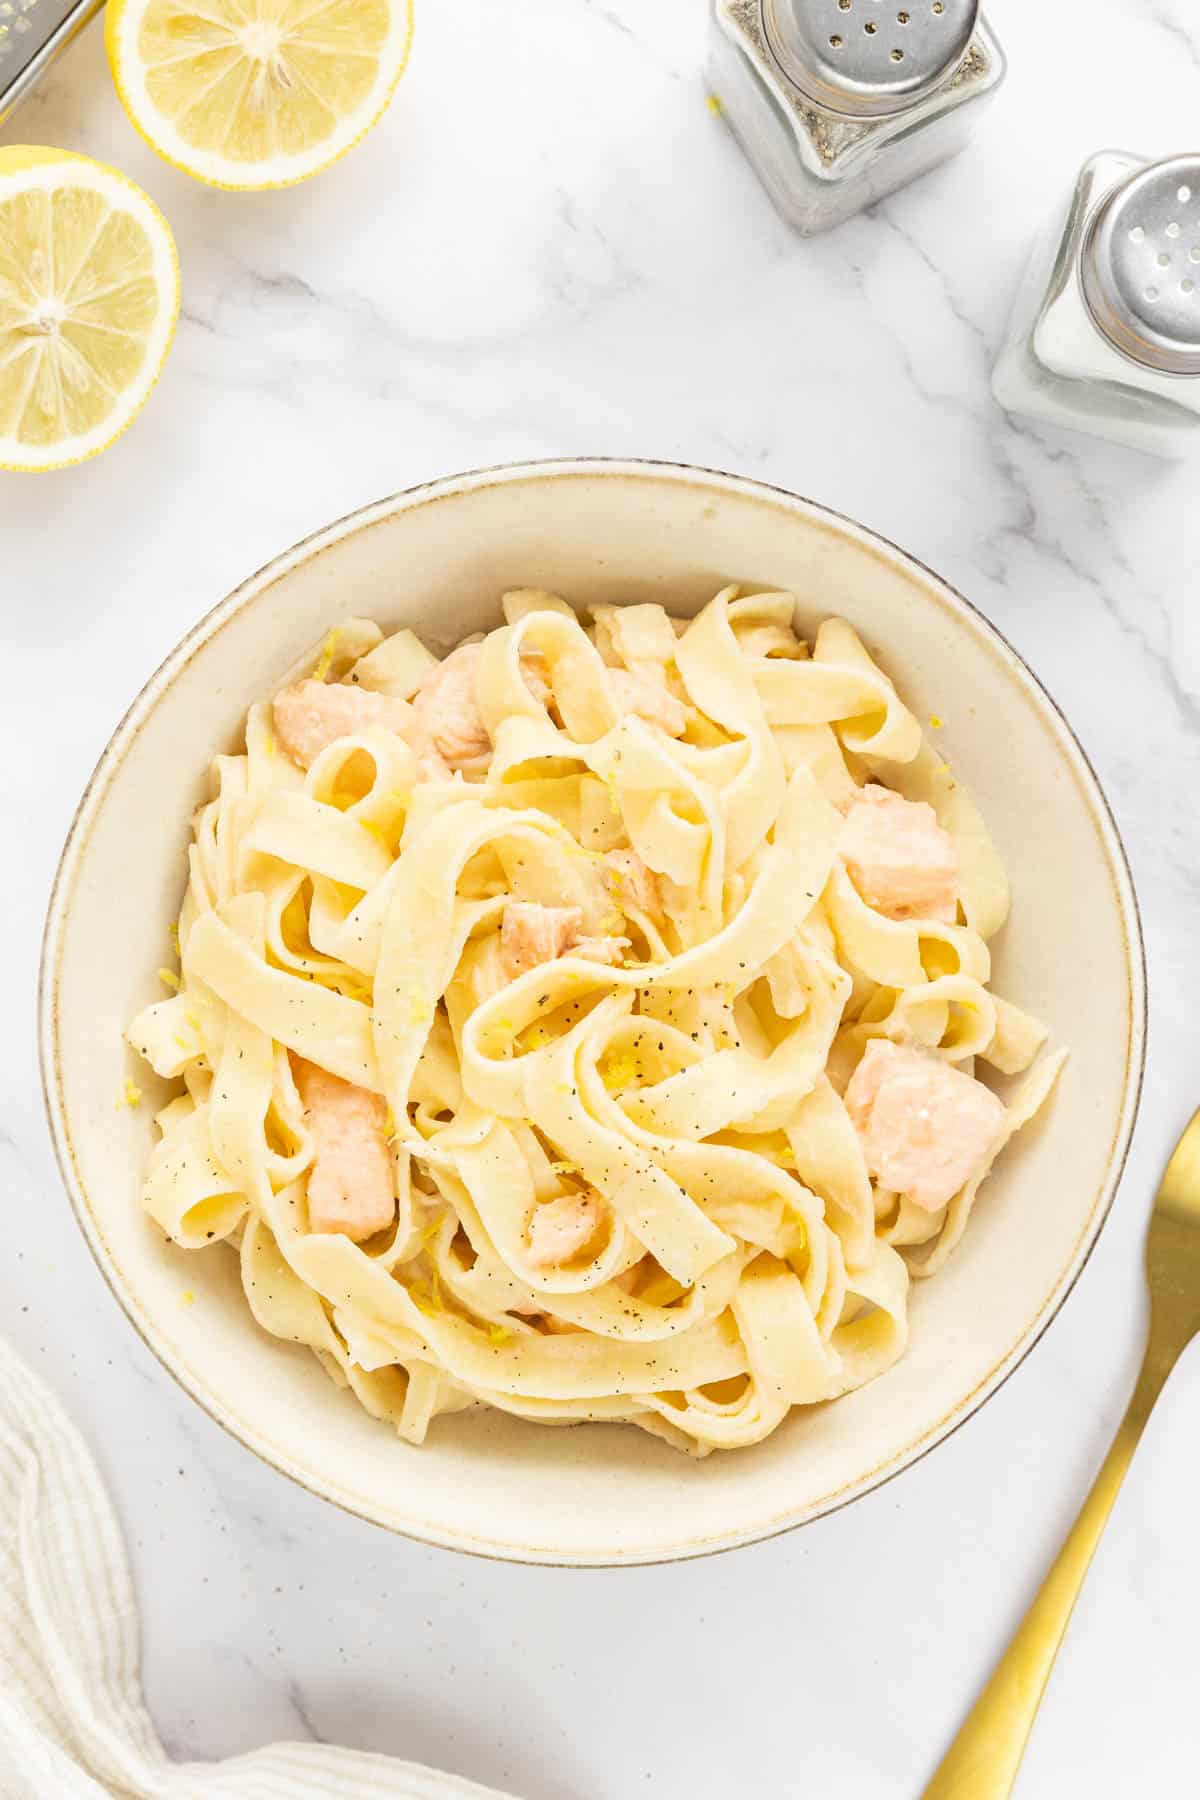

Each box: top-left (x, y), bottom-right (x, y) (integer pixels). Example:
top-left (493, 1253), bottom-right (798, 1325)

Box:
top-left (840, 783), bottom-right (959, 925)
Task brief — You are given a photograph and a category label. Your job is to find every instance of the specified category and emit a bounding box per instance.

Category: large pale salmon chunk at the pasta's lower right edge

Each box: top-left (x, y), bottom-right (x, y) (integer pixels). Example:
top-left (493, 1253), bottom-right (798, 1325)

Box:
top-left (846, 1037), bottom-right (1006, 1213)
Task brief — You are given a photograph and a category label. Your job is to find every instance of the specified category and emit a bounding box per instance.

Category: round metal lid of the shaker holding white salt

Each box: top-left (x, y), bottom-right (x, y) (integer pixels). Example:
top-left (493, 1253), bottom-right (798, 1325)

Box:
top-left (1086, 153), bottom-right (1200, 374)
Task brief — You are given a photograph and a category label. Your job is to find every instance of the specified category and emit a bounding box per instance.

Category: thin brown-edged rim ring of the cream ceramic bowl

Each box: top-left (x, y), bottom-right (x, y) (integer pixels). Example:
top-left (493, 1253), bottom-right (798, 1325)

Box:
top-left (38, 455), bottom-right (1148, 1568)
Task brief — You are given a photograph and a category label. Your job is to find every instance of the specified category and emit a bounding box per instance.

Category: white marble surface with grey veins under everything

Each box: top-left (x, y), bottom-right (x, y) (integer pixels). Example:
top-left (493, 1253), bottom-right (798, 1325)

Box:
top-left (0, 0), bottom-right (1200, 1800)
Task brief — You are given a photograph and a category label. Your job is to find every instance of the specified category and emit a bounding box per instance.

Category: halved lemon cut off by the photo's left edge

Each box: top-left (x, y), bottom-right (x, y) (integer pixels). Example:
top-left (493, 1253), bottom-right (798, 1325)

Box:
top-left (0, 146), bottom-right (180, 470)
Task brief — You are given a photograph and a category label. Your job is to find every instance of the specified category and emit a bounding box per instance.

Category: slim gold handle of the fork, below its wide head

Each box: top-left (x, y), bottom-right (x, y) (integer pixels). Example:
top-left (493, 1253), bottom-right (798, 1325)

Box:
top-left (925, 1357), bottom-right (1166, 1800)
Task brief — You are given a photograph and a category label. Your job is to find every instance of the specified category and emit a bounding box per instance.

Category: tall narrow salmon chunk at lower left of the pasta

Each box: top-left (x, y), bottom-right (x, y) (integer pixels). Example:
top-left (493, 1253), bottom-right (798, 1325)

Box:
top-left (295, 1058), bottom-right (396, 1244)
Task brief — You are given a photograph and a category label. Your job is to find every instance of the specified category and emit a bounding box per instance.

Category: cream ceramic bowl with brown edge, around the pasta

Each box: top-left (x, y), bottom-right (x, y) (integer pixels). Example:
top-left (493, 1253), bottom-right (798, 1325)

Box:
top-left (41, 463), bottom-right (1144, 1564)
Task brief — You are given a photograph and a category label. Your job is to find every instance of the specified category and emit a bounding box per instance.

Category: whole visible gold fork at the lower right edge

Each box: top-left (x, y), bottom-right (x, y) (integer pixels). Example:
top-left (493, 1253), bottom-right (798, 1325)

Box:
top-left (925, 1112), bottom-right (1200, 1800)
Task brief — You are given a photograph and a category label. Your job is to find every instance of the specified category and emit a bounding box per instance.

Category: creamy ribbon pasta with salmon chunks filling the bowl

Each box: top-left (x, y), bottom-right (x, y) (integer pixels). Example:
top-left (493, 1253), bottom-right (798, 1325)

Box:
top-left (128, 587), bottom-right (1063, 1454)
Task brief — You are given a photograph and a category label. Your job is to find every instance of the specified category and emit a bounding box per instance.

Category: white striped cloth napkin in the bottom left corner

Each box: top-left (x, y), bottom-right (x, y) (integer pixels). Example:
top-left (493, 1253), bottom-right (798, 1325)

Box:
top-left (0, 1341), bottom-right (518, 1800)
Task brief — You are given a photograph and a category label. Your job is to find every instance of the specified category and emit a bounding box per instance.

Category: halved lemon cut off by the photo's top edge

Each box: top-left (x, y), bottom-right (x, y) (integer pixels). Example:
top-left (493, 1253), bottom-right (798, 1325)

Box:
top-left (104, 0), bottom-right (412, 187)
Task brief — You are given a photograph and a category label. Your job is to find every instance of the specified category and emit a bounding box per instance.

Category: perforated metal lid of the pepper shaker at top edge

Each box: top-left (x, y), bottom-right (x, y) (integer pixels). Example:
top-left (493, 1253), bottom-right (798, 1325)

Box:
top-left (761, 0), bottom-right (979, 119)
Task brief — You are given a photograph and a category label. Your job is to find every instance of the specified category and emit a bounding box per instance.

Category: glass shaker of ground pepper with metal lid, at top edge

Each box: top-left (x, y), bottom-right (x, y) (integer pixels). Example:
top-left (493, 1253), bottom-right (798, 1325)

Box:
top-left (709, 0), bottom-right (1006, 234)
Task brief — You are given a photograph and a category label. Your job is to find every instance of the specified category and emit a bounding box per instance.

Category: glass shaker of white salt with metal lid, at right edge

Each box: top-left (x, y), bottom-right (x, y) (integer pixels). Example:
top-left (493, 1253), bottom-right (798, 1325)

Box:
top-left (991, 149), bottom-right (1200, 457)
